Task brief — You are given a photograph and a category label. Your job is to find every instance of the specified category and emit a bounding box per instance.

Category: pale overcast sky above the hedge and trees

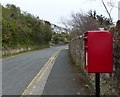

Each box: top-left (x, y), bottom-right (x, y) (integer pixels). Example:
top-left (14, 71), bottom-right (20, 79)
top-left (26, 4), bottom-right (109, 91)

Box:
top-left (0, 0), bottom-right (120, 26)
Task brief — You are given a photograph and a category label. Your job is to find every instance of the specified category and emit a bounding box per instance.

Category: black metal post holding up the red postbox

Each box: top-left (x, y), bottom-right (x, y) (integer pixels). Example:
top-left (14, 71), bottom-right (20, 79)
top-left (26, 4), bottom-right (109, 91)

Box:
top-left (95, 73), bottom-right (100, 97)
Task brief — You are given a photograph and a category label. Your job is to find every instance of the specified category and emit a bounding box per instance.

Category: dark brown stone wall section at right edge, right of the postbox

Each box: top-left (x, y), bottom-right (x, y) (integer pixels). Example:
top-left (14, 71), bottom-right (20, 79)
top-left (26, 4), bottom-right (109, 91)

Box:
top-left (113, 20), bottom-right (120, 95)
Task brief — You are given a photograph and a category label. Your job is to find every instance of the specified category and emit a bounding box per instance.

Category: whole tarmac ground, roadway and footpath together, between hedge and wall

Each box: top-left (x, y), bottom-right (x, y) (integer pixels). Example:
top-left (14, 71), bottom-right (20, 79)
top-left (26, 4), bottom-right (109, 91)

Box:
top-left (2, 46), bottom-right (86, 96)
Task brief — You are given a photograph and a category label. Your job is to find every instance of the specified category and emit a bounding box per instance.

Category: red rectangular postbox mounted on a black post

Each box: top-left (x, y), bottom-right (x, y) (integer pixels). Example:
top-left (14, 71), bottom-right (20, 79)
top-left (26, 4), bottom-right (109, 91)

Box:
top-left (84, 31), bottom-right (113, 73)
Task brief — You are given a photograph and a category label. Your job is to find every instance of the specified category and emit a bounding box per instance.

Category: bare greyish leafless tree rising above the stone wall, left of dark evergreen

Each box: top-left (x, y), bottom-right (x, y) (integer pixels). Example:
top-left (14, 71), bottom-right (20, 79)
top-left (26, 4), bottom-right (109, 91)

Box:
top-left (70, 12), bottom-right (99, 35)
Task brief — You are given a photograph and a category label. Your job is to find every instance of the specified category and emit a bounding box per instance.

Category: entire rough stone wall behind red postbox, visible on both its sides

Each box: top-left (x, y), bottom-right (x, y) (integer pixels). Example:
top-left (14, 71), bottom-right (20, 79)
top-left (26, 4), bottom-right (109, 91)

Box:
top-left (69, 21), bottom-right (120, 96)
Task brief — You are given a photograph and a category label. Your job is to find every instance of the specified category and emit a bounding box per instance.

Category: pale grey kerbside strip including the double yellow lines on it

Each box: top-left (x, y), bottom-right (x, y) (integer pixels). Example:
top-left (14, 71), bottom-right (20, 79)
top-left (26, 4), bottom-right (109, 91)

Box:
top-left (21, 50), bottom-right (61, 97)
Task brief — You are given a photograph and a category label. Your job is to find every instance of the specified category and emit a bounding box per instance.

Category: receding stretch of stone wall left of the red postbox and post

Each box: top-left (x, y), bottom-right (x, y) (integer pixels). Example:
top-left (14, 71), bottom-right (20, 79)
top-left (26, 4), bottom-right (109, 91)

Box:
top-left (69, 37), bottom-right (94, 95)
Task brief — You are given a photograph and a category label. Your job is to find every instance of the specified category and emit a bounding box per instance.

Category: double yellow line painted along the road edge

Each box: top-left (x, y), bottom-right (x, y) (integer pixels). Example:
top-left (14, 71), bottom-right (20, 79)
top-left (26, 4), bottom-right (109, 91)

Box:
top-left (21, 50), bottom-right (61, 97)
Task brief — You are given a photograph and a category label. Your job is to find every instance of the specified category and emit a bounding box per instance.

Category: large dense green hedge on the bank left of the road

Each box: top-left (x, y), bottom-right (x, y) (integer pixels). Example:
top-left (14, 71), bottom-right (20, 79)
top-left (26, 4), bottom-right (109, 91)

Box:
top-left (2, 4), bottom-right (52, 49)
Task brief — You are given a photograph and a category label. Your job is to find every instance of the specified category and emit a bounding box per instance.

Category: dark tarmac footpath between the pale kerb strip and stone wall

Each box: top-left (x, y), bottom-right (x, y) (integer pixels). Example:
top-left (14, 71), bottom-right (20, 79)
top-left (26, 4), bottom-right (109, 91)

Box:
top-left (43, 49), bottom-right (85, 95)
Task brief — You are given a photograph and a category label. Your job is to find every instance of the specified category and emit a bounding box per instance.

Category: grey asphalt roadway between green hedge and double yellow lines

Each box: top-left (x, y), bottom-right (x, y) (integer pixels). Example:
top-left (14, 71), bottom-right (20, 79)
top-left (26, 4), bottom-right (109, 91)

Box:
top-left (2, 46), bottom-right (67, 95)
